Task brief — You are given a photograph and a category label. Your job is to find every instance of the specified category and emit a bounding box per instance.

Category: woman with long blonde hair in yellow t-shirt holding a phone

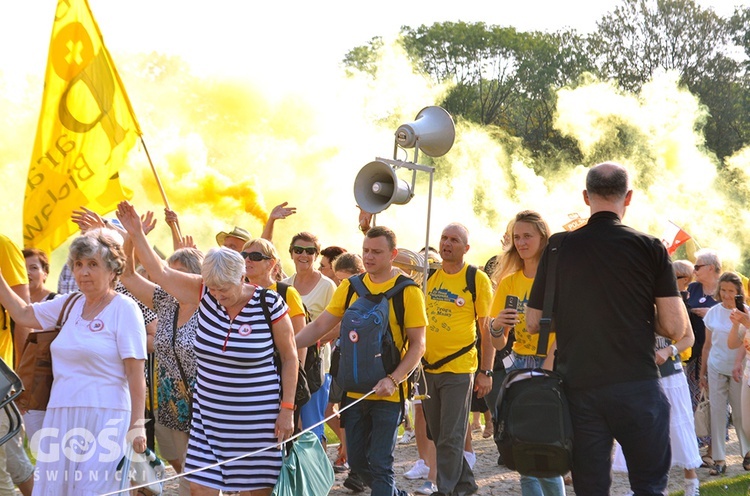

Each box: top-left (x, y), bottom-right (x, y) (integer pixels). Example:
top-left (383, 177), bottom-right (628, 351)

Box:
top-left (490, 210), bottom-right (565, 496)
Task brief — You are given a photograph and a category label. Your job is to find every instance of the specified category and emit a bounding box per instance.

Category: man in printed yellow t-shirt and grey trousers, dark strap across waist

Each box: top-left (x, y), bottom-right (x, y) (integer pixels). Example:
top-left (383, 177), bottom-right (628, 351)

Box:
top-left (422, 223), bottom-right (495, 496)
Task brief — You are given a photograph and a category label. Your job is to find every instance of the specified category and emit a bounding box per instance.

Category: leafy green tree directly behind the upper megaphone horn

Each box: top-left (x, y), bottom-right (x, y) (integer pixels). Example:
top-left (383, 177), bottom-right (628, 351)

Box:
top-left (402, 22), bottom-right (593, 161)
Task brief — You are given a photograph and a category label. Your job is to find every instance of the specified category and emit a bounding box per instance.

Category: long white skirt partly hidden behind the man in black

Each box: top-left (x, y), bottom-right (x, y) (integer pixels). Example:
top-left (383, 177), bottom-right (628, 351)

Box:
top-left (612, 373), bottom-right (703, 472)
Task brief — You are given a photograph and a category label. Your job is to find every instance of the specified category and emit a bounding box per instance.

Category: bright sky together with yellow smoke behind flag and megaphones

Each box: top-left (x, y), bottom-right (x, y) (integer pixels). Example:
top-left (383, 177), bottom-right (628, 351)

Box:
top-left (0, 0), bottom-right (750, 272)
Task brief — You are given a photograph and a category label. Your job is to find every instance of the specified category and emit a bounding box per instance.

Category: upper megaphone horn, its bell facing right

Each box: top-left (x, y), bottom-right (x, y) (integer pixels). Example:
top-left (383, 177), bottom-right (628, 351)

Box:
top-left (396, 106), bottom-right (456, 157)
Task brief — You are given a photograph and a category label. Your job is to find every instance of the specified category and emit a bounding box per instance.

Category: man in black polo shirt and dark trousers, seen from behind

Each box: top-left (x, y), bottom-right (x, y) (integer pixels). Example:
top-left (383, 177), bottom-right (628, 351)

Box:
top-left (526, 163), bottom-right (689, 496)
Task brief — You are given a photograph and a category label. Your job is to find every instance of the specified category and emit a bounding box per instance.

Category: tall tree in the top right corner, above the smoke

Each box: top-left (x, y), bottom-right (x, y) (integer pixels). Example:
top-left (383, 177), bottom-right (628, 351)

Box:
top-left (591, 0), bottom-right (750, 159)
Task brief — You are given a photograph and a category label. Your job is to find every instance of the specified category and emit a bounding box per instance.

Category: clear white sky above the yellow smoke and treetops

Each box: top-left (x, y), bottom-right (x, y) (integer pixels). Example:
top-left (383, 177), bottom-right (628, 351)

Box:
top-left (0, 0), bottom-right (747, 89)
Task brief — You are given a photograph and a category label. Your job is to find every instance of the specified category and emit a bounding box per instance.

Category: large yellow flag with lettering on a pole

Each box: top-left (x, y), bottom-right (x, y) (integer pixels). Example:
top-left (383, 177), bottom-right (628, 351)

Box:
top-left (23, 0), bottom-right (141, 253)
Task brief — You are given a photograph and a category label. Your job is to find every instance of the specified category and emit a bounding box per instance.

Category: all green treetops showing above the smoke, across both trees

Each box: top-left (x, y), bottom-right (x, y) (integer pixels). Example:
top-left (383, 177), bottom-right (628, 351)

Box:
top-left (344, 0), bottom-right (750, 166)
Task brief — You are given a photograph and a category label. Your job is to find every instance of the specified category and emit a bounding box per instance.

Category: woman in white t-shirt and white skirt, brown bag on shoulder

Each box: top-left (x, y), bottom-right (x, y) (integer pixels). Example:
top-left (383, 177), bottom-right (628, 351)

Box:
top-left (0, 230), bottom-right (146, 496)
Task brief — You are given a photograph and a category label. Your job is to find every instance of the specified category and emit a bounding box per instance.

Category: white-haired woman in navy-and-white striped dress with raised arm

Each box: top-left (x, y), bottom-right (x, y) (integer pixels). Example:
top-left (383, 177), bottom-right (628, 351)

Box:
top-left (117, 202), bottom-right (297, 496)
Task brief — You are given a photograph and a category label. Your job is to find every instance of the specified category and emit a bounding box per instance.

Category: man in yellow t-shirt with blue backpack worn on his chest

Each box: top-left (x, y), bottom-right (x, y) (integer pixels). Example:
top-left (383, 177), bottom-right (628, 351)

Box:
top-left (295, 226), bottom-right (427, 496)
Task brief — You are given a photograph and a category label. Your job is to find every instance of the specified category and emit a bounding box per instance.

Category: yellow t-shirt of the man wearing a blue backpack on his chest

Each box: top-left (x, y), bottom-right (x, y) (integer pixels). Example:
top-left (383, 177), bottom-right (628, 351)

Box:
top-left (326, 274), bottom-right (427, 403)
